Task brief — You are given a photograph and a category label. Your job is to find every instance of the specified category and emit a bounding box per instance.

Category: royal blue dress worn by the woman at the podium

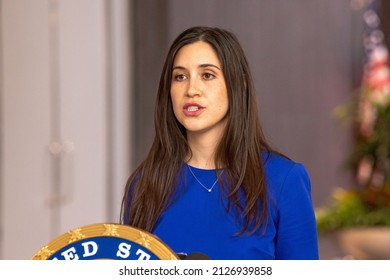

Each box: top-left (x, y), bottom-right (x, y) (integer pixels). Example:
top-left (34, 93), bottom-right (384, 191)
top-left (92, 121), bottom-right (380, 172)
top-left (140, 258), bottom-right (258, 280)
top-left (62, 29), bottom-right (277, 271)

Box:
top-left (149, 154), bottom-right (319, 260)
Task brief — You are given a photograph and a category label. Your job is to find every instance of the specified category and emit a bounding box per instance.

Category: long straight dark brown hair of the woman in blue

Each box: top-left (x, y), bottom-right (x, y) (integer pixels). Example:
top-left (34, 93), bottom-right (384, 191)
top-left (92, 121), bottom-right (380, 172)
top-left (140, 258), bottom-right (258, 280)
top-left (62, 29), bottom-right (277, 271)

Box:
top-left (121, 26), bottom-right (271, 233)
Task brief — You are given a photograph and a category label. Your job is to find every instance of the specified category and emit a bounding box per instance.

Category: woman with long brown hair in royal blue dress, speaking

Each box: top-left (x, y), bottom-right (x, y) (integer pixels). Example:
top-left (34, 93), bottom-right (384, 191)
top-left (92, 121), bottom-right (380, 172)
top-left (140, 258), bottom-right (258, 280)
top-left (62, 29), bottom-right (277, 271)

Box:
top-left (121, 27), bottom-right (318, 259)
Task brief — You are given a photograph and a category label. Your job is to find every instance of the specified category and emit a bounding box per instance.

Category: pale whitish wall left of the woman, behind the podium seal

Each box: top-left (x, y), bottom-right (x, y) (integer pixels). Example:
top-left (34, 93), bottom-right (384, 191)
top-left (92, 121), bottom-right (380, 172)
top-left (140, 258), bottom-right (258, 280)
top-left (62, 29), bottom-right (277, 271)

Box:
top-left (0, 0), bottom-right (132, 259)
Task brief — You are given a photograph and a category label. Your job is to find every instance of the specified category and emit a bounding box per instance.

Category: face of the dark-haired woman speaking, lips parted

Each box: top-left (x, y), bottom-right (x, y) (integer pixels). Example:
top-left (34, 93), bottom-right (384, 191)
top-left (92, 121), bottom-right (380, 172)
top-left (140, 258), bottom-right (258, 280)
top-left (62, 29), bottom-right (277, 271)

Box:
top-left (171, 41), bottom-right (229, 137)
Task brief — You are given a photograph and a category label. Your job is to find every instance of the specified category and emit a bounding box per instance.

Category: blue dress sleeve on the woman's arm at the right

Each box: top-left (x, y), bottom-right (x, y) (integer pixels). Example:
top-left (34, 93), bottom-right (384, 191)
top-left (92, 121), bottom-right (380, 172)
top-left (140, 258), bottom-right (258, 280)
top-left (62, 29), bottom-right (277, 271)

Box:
top-left (275, 163), bottom-right (319, 260)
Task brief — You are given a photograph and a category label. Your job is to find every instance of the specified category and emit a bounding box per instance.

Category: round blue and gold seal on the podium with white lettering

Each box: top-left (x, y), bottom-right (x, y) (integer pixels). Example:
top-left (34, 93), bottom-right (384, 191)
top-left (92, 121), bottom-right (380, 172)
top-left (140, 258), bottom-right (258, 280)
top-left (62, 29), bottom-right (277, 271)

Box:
top-left (32, 224), bottom-right (179, 260)
